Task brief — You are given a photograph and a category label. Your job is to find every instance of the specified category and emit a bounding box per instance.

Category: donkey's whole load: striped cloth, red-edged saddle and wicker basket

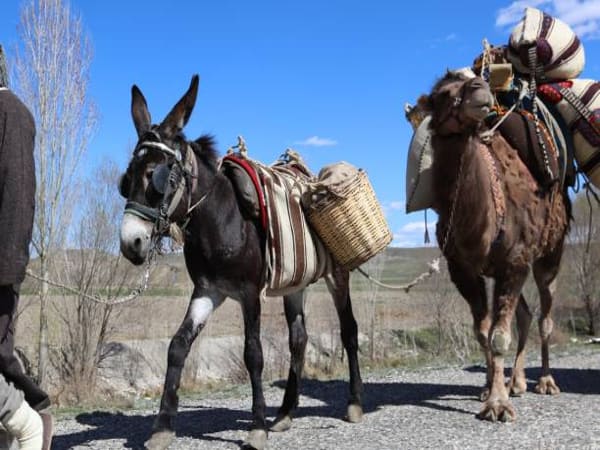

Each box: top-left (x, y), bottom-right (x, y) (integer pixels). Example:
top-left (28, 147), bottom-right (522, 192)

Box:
top-left (221, 144), bottom-right (392, 278)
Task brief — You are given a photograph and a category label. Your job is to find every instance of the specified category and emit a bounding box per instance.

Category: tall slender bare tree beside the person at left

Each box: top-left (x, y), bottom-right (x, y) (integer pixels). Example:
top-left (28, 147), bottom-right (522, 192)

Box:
top-left (14, 0), bottom-right (96, 386)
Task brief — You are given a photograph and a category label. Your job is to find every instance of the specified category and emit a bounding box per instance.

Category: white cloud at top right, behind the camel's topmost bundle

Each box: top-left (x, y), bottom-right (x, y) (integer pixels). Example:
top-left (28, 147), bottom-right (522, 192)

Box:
top-left (496, 0), bottom-right (600, 39)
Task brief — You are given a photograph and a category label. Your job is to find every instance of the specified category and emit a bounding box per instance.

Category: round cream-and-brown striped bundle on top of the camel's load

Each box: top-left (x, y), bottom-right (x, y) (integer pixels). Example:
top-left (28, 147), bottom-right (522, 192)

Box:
top-left (507, 8), bottom-right (585, 82)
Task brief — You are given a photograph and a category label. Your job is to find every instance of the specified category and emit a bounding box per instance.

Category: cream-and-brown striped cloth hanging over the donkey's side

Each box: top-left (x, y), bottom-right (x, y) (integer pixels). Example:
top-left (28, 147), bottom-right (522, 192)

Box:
top-left (255, 164), bottom-right (330, 296)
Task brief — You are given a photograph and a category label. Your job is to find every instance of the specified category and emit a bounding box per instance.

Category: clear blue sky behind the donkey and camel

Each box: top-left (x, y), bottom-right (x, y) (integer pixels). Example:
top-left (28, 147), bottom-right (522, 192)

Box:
top-left (0, 0), bottom-right (600, 246)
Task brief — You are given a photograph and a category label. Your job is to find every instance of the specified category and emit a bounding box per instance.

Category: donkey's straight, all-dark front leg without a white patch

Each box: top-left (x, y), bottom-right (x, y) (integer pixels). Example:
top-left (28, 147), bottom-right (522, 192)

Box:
top-left (241, 294), bottom-right (267, 450)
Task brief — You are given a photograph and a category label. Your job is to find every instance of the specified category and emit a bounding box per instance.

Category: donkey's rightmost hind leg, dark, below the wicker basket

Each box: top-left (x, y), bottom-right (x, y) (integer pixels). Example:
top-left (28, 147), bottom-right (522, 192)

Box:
top-left (325, 266), bottom-right (363, 423)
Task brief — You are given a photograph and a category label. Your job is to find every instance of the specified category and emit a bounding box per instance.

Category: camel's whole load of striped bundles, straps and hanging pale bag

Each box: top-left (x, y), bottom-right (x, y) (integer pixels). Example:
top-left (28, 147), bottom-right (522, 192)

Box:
top-left (406, 4), bottom-right (600, 213)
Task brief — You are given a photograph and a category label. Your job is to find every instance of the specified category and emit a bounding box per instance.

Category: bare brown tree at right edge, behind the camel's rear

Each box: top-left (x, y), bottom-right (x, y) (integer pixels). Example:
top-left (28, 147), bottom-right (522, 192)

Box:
top-left (566, 194), bottom-right (600, 336)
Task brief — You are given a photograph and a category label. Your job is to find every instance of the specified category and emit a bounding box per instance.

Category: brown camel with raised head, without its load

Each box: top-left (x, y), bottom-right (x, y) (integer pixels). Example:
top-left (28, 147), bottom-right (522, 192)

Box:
top-left (419, 71), bottom-right (571, 421)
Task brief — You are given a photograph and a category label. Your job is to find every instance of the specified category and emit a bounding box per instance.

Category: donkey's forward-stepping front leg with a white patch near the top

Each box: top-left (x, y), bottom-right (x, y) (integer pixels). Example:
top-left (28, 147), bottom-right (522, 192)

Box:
top-left (146, 289), bottom-right (225, 450)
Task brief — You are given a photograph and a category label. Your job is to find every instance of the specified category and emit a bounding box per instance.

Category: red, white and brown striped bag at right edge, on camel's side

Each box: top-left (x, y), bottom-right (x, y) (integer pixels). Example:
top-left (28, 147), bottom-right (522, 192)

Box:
top-left (538, 79), bottom-right (600, 187)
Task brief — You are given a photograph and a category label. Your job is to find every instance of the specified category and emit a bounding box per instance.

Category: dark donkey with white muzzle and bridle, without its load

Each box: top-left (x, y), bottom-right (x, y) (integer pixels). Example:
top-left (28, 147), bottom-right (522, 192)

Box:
top-left (119, 75), bottom-right (363, 449)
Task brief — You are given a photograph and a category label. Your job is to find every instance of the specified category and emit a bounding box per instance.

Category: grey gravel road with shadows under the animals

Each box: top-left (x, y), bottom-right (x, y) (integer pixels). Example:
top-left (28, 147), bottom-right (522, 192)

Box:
top-left (52, 345), bottom-right (600, 450)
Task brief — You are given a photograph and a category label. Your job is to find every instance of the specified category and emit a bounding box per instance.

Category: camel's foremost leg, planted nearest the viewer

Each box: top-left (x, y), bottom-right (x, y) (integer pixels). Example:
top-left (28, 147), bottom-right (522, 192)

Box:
top-left (479, 267), bottom-right (529, 422)
